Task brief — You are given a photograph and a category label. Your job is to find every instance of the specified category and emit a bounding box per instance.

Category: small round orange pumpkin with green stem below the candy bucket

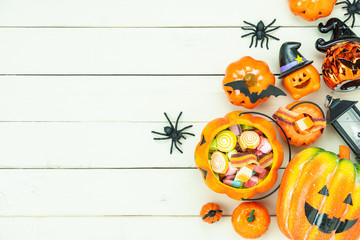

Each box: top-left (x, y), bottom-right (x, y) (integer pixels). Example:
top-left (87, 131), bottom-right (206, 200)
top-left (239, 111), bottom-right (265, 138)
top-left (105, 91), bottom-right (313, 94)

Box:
top-left (231, 202), bottom-right (271, 238)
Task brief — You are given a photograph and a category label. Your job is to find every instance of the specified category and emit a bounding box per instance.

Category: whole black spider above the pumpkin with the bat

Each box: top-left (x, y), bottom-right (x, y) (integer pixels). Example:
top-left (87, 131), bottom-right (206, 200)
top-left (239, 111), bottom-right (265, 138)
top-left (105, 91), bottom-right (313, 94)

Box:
top-left (241, 19), bottom-right (280, 49)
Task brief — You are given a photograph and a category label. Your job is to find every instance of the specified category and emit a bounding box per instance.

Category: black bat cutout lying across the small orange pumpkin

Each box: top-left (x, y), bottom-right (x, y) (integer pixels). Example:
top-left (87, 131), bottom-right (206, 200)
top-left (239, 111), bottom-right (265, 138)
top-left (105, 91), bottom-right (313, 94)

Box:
top-left (225, 80), bottom-right (286, 103)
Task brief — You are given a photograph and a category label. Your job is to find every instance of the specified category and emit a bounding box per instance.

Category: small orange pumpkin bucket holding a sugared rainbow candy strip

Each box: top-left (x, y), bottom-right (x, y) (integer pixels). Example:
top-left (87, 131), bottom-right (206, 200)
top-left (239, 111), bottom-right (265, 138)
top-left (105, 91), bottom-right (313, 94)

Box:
top-left (273, 101), bottom-right (326, 147)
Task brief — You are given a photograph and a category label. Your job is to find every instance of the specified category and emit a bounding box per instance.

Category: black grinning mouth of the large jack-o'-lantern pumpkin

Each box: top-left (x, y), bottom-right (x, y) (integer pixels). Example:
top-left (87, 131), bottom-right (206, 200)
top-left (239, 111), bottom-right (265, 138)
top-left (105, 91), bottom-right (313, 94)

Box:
top-left (305, 202), bottom-right (358, 234)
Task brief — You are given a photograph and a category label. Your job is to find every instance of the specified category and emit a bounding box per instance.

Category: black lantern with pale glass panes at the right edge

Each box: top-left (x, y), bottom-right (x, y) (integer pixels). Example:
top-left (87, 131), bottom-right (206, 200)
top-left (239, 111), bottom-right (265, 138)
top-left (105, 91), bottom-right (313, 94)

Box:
top-left (325, 95), bottom-right (360, 161)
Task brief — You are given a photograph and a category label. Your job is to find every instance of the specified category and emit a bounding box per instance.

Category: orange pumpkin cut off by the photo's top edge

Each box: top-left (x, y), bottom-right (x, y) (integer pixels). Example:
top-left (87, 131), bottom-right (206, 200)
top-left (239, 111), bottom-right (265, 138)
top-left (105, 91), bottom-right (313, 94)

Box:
top-left (289, 0), bottom-right (337, 21)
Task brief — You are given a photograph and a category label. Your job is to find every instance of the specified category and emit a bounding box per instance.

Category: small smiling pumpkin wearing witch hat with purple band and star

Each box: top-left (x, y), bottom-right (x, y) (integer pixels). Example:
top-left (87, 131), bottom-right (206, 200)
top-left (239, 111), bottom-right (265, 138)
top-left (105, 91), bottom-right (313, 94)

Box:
top-left (279, 42), bottom-right (320, 100)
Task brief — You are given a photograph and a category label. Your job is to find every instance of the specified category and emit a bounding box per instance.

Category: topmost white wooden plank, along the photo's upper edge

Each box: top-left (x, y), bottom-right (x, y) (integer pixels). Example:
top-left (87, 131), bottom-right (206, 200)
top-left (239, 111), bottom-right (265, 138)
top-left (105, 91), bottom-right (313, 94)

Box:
top-left (0, 0), bottom-right (345, 27)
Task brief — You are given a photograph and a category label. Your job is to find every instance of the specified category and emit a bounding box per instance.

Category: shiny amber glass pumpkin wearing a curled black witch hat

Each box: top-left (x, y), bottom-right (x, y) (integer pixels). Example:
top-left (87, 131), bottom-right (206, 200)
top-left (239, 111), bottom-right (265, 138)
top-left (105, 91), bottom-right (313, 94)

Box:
top-left (316, 18), bottom-right (360, 91)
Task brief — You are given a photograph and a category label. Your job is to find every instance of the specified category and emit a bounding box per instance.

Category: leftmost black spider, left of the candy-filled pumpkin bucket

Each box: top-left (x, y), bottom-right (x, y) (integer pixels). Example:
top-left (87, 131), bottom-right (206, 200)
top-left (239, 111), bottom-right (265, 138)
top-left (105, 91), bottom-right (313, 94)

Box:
top-left (151, 112), bottom-right (195, 154)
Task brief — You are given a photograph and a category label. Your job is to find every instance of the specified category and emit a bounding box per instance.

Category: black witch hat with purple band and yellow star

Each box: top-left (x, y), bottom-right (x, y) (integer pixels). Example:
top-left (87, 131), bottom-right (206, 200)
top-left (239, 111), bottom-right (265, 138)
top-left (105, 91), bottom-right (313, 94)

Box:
top-left (279, 42), bottom-right (313, 78)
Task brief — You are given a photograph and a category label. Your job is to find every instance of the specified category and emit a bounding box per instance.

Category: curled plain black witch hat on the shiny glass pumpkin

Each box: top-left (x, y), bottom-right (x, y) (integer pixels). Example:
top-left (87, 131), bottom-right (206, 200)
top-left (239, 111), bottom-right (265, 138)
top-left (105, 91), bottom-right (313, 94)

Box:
top-left (315, 18), bottom-right (360, 52)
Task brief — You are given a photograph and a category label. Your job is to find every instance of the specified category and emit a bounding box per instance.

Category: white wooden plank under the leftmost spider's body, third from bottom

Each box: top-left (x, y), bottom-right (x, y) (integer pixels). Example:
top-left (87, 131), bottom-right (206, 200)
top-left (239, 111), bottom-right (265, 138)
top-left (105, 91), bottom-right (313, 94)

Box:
top-left (0, 122), bottom-right (355, 168)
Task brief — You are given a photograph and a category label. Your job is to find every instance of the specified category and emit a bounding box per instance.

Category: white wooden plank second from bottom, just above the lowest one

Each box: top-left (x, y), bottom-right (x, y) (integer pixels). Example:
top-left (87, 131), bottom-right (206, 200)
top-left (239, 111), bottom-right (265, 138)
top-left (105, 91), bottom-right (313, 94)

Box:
top-left (0, 168), bottom-right (283, 216)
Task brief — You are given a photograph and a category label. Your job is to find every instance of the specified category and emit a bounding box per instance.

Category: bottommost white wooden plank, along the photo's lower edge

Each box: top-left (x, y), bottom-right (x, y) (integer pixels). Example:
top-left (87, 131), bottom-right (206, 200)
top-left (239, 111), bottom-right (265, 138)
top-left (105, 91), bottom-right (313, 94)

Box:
top-left (0, 217), bottom-right (286, 240)
